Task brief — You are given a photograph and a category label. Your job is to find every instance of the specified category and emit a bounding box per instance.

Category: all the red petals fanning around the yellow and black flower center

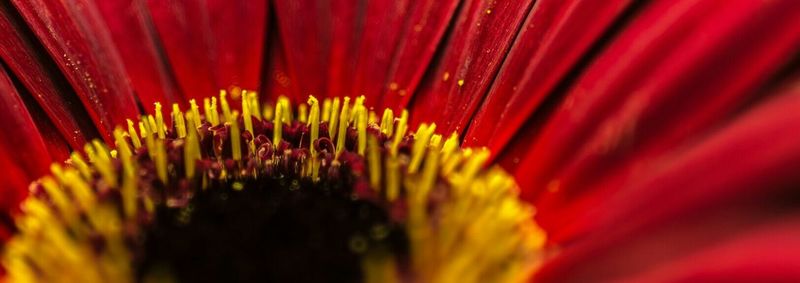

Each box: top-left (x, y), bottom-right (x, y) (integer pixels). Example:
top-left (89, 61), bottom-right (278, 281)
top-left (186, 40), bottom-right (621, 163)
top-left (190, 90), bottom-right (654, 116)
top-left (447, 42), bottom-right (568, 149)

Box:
top-left (0, 0), bottom-right (800, 282)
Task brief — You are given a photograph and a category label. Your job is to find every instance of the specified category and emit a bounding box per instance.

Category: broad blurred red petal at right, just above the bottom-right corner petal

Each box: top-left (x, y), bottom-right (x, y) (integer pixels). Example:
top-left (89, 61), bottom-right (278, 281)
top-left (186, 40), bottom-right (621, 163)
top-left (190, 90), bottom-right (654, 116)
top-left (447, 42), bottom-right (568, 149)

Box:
top-left (541, 86), bottom-right (800, 282)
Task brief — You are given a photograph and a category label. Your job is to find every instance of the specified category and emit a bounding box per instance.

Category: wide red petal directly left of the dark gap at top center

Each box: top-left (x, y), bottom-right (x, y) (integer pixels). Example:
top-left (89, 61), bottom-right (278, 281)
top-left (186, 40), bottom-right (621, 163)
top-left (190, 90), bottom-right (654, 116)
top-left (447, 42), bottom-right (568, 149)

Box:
top-left (147, 0), bottom-right (267, 98)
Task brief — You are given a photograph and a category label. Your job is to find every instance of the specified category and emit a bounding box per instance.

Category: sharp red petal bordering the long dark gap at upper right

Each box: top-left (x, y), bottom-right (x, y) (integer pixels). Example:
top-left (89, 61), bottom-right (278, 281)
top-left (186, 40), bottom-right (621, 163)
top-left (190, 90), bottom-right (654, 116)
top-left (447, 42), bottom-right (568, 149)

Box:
top-left (464, 0), bottom-right (631, 152)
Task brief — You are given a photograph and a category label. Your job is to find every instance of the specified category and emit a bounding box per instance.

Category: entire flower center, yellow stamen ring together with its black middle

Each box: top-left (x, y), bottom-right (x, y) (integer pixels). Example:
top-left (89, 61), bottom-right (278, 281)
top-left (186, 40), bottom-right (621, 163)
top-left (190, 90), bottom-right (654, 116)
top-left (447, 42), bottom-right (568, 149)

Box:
top-left (3, 91), bottom-right (544, 282)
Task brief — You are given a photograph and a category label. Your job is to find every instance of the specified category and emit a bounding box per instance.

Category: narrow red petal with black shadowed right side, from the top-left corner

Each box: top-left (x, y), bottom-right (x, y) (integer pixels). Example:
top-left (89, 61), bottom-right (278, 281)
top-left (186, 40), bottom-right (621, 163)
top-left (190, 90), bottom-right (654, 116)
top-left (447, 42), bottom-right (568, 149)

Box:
top-left (0, 4), bottom-right (99, 148)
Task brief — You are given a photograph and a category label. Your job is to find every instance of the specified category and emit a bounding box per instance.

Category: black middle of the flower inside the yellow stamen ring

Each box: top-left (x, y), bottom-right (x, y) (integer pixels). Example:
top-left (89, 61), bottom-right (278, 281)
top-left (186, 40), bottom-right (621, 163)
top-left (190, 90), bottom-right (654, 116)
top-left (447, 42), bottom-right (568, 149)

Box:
top-left (138, 176), bottom-right (407, 282)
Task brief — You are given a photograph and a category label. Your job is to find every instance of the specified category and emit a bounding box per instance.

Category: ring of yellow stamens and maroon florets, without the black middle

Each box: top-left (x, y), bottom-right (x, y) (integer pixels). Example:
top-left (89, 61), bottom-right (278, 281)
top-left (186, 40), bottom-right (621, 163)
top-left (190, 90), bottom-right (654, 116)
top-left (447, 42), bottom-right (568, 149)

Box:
top-left (3, 91), bottom-right (544, 282)
